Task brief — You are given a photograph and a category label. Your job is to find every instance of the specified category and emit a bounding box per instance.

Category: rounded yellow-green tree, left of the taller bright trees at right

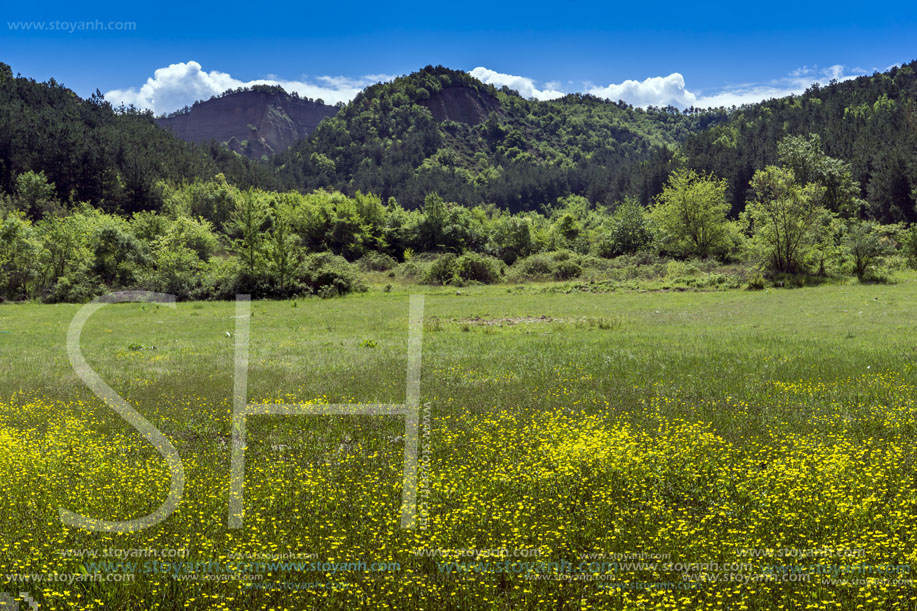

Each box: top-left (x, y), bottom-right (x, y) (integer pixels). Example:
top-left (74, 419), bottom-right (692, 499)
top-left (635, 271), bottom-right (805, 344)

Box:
top-left (649, 169), bottom-right (730, 257)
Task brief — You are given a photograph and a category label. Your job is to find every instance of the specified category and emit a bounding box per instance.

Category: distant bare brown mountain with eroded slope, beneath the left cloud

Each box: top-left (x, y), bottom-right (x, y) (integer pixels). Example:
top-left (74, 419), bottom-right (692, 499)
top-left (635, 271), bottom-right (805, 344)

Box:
top-left (156, 85), bottom-right (338, 159)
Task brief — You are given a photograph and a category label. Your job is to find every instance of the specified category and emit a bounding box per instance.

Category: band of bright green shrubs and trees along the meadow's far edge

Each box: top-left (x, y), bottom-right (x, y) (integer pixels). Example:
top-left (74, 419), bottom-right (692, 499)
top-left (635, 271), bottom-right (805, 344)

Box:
top-left (0, 134), bottom-right (917, 302)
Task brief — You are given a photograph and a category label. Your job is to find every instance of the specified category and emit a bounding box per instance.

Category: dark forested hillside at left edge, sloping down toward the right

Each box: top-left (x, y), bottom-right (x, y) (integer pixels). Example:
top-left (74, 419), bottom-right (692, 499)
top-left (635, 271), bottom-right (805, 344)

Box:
top-left (0, 64), bottom-right (279, 213)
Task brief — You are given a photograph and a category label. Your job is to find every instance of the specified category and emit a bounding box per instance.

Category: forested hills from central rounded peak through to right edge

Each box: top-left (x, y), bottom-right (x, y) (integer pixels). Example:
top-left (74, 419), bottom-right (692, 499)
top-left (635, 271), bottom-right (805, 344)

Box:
top-left (273, 62), bottom-right (917, 222)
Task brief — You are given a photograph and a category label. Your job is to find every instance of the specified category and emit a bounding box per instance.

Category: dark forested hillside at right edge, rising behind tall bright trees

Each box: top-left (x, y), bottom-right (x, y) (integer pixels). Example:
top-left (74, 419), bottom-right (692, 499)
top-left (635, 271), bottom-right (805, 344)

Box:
top-left (682, 62), bottom-right (917, 223)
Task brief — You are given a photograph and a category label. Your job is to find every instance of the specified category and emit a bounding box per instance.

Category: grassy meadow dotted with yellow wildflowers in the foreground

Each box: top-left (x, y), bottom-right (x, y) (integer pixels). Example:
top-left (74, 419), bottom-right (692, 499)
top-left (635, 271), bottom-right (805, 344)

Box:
top-left (0, 276), bottom-right (917, 610)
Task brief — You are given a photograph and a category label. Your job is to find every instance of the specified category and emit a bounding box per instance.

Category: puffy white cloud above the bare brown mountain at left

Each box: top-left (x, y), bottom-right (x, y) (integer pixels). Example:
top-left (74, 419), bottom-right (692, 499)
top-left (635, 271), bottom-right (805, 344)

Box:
top-left (105, 61), bottom-right (392, 114)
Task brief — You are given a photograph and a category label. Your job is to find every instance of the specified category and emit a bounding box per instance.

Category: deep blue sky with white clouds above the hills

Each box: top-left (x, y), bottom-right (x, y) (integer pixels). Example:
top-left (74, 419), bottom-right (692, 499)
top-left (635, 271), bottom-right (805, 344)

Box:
top-left (0, 0), bottom-right (917, 112)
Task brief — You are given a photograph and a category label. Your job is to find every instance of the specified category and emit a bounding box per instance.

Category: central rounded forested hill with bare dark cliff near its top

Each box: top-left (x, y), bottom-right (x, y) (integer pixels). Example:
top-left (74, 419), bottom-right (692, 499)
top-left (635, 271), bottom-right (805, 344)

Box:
top-left (274, 66), bottom-right (727, 210)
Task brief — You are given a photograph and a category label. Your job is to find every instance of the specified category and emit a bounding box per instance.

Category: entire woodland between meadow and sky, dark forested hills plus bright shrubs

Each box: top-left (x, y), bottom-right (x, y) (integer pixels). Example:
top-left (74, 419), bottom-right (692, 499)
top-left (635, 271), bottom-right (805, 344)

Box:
top-left (0, 58), bottom-right (917, 301)
